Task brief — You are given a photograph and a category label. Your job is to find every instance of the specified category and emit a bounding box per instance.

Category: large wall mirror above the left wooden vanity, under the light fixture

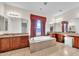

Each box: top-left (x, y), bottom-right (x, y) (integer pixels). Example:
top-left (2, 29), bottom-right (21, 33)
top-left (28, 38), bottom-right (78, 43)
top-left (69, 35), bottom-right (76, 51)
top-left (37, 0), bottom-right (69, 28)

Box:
top-left (8, 17), bottom-right (28, 33)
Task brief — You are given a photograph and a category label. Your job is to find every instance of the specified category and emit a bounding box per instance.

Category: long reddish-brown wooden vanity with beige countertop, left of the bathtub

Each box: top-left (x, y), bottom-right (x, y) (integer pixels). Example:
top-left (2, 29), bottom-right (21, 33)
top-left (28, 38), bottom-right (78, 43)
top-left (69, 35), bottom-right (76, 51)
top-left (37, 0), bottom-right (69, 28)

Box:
top-left (0, 33), bottom-right (29, 52)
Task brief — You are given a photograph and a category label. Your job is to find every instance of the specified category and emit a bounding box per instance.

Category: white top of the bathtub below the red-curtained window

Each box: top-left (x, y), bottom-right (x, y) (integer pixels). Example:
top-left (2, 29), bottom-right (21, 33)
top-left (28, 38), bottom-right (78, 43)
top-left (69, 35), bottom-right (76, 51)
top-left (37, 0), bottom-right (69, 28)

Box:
top-left (30, 36), bottom-right (55, 43)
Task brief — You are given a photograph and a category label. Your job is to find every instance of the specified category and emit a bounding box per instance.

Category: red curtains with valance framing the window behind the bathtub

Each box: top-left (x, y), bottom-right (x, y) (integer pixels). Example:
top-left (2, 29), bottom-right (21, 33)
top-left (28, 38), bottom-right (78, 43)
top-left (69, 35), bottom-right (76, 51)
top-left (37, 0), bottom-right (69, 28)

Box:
top-left (30, 14), bottom-right (46, 37)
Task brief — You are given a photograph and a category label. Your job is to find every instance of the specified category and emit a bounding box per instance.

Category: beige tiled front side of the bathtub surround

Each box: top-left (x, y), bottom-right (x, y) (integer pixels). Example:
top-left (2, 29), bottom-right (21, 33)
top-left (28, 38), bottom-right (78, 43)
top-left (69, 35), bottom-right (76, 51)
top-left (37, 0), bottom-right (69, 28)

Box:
top-left (30, 38), bottom-right (56, 53)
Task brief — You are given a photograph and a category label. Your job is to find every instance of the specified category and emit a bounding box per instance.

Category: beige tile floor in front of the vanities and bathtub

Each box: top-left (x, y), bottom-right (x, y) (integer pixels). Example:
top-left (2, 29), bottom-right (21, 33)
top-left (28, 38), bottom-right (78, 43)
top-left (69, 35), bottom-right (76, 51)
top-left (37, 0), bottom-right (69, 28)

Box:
top-left (0, 43), bottom-right (79, 56)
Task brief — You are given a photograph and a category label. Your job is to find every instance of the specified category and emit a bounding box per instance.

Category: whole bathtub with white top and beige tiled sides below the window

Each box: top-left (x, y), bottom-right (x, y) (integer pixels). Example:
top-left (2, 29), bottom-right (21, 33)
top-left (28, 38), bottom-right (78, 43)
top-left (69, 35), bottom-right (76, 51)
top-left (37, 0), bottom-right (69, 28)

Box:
top-left (30, 36), bottom-right (56, 52)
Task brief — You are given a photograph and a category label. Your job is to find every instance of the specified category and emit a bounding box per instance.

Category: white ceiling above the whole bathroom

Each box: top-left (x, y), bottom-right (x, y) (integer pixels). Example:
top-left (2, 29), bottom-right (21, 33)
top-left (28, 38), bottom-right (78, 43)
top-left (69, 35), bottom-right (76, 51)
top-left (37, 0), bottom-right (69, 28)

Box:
top-left (6, 2), bottom-right (79, 16)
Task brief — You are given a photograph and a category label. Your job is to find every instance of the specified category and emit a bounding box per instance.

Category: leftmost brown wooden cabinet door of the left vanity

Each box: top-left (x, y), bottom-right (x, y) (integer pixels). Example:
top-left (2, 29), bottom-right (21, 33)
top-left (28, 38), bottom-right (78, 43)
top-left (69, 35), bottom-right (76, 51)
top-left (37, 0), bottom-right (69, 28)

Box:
top-left (0, 38), bottom-right (10, 51)
